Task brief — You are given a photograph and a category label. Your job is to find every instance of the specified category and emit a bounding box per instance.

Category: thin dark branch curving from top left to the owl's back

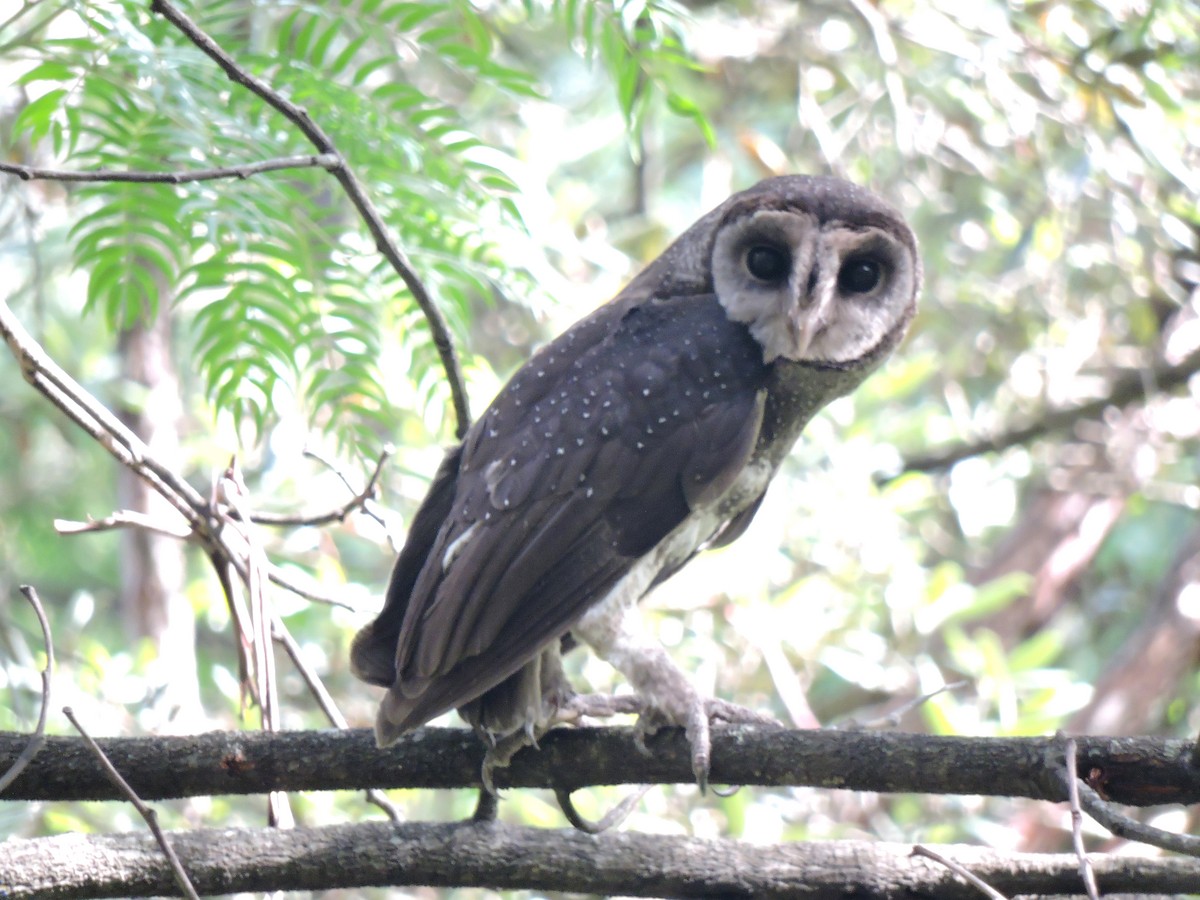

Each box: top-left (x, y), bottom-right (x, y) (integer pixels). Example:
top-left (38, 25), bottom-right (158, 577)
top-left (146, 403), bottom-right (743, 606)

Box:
top-left (150, 0), bottom-right (470, 438)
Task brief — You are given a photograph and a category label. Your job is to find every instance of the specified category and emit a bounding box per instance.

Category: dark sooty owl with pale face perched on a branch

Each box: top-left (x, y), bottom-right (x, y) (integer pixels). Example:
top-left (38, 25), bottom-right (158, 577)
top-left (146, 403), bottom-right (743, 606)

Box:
top-left (352, 175), bottom-right (920, 784)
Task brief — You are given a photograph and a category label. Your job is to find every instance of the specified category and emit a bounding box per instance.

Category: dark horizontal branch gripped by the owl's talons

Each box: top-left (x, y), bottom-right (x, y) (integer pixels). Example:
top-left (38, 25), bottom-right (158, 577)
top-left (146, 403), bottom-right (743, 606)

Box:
top-left (0, 727), bottom-right (1200, 805)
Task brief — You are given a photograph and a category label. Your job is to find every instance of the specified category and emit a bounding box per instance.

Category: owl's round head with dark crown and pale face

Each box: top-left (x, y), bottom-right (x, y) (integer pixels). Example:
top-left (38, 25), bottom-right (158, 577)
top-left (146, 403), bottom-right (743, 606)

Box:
top-left (709, 175), bottom-right (920, 367)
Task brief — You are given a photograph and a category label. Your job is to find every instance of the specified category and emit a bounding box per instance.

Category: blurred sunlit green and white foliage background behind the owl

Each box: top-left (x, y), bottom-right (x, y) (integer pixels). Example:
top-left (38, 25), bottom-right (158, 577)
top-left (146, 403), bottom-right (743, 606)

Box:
top-left (0, 0), bottom-right (1200, 895)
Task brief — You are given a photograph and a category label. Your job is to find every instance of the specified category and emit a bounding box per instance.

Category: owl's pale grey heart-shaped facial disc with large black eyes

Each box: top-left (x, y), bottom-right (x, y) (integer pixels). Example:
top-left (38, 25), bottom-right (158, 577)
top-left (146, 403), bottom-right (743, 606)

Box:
top-left (712, 209), bottom-right (918, 362)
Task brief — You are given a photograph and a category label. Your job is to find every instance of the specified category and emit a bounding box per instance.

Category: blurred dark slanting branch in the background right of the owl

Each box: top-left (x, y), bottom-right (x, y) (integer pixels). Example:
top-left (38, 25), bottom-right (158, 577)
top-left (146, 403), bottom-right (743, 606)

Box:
top-left (881, 352), bottom-right (1200, 482)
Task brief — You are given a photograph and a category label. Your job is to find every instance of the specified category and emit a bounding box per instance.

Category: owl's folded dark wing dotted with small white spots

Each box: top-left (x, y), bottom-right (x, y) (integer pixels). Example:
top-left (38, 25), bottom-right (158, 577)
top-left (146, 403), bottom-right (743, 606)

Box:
top-left (355, 294), bottom-right (767, 731)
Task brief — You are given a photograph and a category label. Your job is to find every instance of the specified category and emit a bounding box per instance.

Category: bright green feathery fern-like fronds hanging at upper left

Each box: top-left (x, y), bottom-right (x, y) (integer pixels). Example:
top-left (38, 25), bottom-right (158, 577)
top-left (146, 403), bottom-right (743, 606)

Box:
top-left (4, 0), bottom-right (702, 444)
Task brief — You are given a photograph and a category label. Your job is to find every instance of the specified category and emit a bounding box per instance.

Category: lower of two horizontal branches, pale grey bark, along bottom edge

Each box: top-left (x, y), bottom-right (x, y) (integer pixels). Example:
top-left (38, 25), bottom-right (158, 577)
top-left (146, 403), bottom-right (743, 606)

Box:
top-left (0, 822), bottom-right (1200, 900)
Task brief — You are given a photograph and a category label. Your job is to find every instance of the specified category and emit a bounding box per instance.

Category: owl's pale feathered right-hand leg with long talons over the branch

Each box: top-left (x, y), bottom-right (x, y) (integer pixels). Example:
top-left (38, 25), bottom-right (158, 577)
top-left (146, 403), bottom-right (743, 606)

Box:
top-left (572, 602), bottom-right (779, 790)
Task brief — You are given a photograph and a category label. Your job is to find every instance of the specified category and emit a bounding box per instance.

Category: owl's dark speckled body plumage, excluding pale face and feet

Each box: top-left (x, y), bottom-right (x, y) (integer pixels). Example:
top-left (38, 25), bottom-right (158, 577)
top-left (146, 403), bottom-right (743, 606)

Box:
top-left (352, 176), bottom-right (920, 740)
